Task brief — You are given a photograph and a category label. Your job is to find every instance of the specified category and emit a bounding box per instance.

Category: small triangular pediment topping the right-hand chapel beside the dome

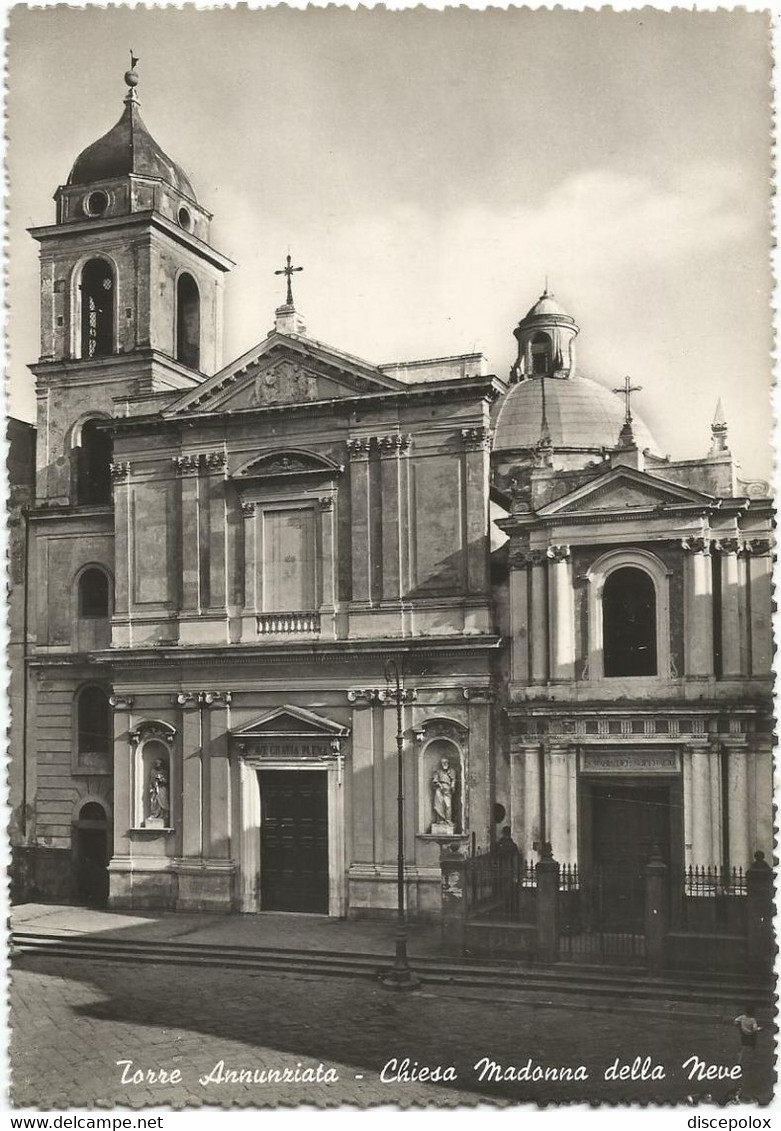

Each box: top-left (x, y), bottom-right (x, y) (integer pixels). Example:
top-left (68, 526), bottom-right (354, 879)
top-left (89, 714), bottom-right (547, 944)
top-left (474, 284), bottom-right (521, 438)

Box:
top-left (538, 467), bottom-right (715, 516)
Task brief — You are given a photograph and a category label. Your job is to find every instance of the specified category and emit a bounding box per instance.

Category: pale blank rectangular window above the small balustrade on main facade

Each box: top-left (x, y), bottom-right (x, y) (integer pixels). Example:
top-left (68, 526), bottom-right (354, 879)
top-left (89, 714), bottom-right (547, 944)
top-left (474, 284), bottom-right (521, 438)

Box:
top-left (262, 508), bottom-right (318, 612)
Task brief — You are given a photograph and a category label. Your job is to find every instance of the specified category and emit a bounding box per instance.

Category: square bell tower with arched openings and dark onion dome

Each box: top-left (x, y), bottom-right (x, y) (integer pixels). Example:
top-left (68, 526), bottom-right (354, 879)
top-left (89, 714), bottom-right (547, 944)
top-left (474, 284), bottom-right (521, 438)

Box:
top-left (31, 55), bottom-right (233, 506)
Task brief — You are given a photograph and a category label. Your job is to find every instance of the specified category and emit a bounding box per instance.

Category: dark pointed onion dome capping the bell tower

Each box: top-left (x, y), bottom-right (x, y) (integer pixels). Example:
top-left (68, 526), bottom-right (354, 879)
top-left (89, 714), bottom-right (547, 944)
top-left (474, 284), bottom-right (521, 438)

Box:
top-left (68, 59), bottom-right (197, 202)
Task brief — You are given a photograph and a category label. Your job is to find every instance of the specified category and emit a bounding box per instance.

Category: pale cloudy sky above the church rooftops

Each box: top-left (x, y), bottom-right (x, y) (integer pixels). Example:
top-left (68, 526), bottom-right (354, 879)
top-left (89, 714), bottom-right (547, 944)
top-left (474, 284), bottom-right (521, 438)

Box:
top-left (6, 7), bottom-right (772, 478)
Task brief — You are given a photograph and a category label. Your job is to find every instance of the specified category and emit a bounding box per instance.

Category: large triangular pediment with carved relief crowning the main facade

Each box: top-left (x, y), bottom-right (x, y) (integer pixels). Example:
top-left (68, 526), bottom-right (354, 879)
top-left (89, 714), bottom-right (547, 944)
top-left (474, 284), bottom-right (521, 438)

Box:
top-left (164, 331), bottom-right (403, 416)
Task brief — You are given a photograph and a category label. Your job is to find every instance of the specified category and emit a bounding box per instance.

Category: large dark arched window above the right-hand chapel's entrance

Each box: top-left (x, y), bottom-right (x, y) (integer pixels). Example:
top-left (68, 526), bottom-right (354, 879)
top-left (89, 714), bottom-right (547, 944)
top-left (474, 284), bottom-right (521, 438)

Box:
top-left (602, 566), bottom-right (657, 676)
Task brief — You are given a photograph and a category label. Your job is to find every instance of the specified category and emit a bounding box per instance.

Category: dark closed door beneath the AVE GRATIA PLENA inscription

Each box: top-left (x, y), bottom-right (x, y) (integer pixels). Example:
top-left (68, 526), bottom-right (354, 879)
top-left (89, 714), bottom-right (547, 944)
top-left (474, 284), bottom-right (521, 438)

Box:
top-left (258, 770), bottom-right (329, 915)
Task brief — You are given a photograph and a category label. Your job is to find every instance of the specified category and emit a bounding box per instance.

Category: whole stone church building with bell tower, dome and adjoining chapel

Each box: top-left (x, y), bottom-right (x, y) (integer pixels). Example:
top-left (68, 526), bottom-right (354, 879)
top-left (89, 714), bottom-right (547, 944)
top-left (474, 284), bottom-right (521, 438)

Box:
top-left (11, 70), bottom-right (772, 916)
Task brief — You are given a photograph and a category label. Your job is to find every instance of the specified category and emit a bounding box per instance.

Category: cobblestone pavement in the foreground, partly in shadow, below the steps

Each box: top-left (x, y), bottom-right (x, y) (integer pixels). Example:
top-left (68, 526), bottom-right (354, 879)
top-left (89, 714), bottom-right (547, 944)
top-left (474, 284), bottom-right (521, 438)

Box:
top-left (10, 955), bottom-right (773, 1111)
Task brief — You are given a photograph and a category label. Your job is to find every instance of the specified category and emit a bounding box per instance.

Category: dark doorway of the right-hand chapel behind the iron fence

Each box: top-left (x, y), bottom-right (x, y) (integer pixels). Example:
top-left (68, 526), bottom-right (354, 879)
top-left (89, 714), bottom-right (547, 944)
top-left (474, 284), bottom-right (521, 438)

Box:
top-left (590, 783), bottom-right (670, 932)
